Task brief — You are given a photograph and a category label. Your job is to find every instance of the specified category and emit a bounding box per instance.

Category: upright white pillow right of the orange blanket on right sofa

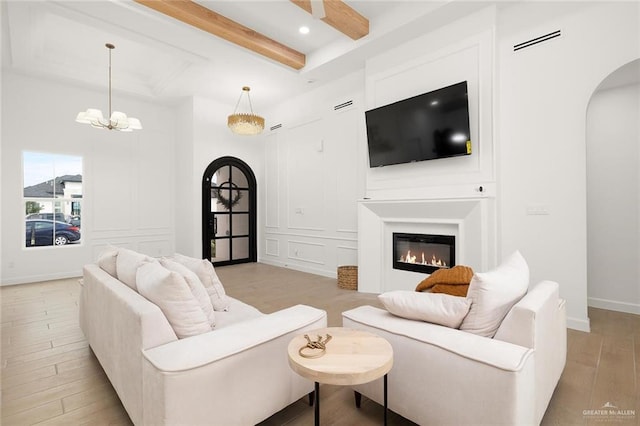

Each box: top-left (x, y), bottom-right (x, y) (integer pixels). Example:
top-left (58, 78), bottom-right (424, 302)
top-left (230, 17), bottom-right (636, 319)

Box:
top-left (460, 251), bottom-right (529, 337)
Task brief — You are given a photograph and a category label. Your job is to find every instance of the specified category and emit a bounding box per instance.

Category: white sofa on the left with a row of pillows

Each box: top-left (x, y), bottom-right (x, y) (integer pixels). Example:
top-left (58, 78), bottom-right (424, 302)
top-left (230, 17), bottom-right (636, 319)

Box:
top-left (80, 250), bottom-right (327, 425)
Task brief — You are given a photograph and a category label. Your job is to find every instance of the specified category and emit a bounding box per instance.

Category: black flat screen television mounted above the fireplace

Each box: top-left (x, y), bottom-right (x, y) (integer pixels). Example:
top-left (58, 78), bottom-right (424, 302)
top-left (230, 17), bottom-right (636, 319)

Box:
top-left (365, 81), bottom-right (471, 167)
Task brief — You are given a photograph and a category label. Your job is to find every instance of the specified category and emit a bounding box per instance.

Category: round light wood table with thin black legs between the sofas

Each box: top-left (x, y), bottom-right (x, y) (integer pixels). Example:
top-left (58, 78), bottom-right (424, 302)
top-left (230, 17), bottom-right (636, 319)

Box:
top-left (287, 327), bottom-right (393, 426)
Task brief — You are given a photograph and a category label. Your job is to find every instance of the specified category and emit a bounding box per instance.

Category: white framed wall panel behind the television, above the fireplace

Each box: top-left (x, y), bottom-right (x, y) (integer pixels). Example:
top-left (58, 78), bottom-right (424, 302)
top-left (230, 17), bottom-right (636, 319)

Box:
top-left (364, 7), bottom-right (495, 199)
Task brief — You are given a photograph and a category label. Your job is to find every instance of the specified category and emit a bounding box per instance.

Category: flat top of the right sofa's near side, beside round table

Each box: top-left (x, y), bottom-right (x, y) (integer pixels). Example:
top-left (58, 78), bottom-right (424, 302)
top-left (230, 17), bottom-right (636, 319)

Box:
top-left (342, 306), bottom-right (533, 371)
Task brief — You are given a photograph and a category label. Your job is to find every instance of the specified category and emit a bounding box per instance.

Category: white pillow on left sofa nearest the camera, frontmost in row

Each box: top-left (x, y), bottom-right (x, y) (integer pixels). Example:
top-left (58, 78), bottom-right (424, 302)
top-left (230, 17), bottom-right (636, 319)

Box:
top-left (136, 262), bottom-right (211, 339)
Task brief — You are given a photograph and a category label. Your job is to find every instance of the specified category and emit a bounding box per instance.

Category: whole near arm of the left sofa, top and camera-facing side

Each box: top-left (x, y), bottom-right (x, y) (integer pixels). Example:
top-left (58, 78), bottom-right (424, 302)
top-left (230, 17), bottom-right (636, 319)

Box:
top-left (143, 305), bottom-right (327, 426)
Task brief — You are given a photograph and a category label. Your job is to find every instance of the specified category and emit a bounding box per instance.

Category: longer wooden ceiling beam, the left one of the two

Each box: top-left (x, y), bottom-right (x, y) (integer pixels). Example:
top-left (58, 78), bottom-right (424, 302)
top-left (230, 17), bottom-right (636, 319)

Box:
top-left (135, 0), bottom-right (306, 70)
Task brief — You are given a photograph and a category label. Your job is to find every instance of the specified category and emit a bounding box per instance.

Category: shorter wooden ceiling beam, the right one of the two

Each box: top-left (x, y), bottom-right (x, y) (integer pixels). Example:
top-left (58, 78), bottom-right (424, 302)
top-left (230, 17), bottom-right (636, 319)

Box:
top-left (291, 0), bottom-right (369, 40)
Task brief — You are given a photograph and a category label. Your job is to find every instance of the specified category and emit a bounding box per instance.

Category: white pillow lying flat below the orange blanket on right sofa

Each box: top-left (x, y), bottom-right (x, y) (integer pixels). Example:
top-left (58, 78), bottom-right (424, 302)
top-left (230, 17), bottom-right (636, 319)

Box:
top-left (378, 290), bottom-right (471, 328)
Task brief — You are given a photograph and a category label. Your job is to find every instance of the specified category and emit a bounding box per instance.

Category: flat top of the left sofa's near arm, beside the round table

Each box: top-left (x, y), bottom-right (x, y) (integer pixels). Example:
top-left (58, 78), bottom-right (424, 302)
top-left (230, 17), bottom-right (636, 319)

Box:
top-left (144, 305), bottom-right (327, 372)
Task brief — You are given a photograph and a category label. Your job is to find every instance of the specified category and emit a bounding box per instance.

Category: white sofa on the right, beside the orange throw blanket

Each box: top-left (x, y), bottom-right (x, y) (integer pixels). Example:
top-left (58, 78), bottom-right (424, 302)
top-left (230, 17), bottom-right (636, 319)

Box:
top-left (342, 281), bottom-right (566, 426)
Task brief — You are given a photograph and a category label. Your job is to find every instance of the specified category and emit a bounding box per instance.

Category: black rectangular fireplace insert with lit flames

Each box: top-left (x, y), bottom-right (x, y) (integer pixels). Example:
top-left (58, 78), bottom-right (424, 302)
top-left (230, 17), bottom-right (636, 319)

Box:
top-left (393, 232), bottom-right (456, 274)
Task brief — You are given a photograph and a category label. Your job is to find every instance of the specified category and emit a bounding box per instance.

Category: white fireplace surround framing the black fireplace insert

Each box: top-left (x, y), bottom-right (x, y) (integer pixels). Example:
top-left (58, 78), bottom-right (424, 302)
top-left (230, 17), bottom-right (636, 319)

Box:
top-left (358, 197), bottom-right (496, 294)
